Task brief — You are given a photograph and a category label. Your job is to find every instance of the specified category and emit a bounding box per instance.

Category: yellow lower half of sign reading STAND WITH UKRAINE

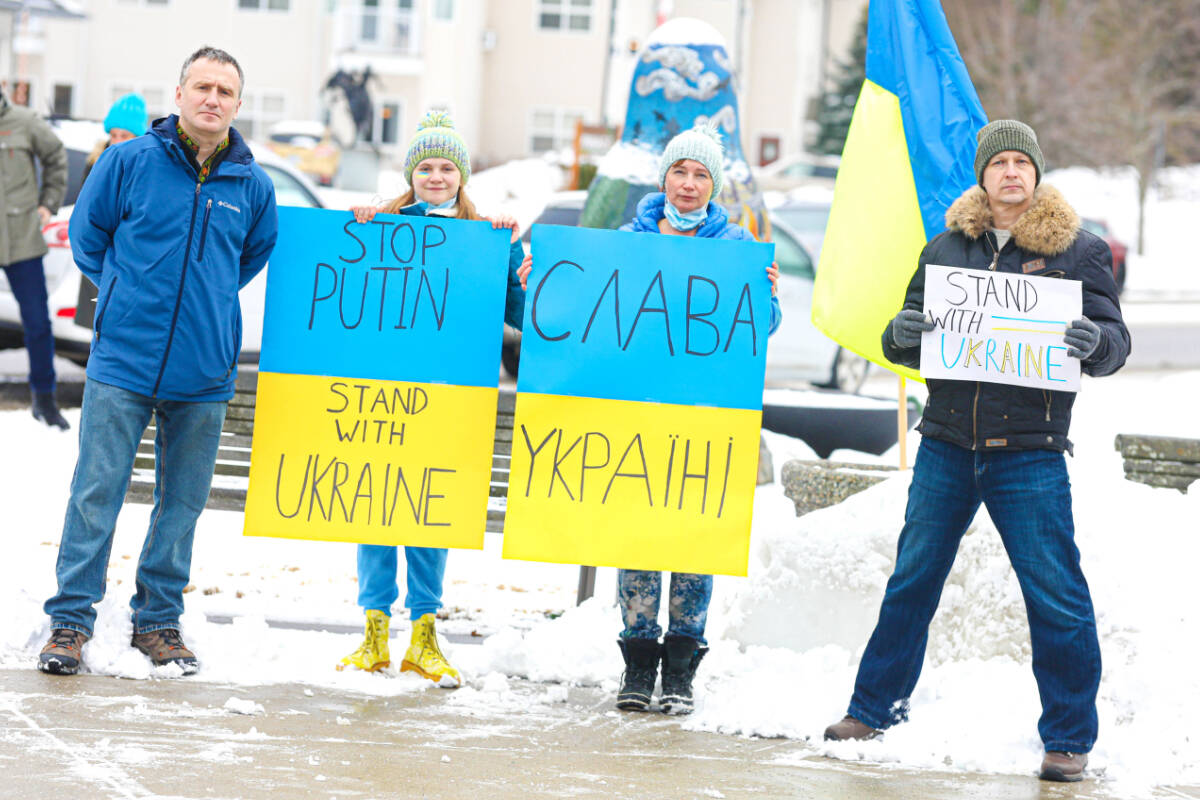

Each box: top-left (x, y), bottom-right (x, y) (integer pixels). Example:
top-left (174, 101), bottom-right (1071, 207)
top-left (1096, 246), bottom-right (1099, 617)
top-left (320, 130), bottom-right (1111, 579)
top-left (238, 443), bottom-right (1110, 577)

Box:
top-left (245, 372), bottom-right (498, 549)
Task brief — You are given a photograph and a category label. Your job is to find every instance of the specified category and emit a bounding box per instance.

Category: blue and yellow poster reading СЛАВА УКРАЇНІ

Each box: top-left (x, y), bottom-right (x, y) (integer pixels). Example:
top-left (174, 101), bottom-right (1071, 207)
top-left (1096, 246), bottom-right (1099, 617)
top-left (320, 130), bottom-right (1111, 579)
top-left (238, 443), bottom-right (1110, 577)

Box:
top-left (504, 225), bottom-right (774, 575)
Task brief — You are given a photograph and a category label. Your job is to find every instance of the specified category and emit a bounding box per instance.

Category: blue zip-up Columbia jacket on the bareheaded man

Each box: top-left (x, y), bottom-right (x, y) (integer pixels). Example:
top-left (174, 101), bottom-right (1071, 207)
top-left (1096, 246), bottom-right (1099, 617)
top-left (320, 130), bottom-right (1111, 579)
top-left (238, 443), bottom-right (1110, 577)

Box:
top-left (70, 115), bottom-right (278, 401)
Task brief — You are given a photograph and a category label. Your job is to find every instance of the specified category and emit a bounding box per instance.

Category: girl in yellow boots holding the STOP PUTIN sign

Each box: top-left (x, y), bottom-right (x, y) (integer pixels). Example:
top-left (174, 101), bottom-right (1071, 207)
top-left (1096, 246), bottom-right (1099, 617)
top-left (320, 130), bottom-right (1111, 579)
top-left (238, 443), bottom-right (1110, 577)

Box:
top-left (337, 112), bottom-right (524, 688)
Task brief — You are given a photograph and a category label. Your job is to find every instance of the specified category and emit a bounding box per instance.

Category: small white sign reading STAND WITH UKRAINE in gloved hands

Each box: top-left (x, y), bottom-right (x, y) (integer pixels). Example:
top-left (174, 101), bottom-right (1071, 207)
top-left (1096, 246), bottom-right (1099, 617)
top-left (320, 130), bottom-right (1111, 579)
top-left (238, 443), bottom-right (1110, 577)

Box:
top-left (920, 264), bottom-right (1084, 392)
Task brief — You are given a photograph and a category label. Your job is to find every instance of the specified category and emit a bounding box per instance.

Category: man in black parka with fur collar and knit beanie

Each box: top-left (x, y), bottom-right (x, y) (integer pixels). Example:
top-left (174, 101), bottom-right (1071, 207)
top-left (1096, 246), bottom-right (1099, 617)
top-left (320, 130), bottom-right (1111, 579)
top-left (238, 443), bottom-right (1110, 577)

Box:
top-left (826, 120), bottom-right (1129, 781)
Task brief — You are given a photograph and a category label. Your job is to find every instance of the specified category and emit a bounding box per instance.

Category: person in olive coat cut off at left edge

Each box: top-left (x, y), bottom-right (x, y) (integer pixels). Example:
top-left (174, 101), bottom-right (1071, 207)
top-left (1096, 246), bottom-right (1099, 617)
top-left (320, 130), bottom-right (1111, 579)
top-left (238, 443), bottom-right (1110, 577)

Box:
top-left (0, 82), bottom-right (71, 431)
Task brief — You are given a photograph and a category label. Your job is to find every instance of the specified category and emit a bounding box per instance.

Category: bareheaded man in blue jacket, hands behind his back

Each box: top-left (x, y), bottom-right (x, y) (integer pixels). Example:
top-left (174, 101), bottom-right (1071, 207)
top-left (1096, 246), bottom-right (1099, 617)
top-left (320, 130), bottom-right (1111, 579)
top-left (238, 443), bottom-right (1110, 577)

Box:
top-left (38, 47), bottom-right (277, 675)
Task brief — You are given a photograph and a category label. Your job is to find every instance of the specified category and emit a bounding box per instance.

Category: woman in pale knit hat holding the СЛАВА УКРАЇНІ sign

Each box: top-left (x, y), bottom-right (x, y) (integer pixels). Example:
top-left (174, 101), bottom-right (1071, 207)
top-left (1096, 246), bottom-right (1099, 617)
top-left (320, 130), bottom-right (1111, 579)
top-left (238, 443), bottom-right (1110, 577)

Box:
top-left (518, 126), bottom-right (782, 714)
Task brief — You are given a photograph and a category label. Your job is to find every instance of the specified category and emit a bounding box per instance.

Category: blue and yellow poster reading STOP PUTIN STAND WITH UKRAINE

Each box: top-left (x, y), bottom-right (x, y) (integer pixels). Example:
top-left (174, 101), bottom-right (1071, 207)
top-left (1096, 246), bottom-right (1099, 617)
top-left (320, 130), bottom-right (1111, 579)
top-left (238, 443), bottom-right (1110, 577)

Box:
top-left (245, 207), bottom-right (509, 549)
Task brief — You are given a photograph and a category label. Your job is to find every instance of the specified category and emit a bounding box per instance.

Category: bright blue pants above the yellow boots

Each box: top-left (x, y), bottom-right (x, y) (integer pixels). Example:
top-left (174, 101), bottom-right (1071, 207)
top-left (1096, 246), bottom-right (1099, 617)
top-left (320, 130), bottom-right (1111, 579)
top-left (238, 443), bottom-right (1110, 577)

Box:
top-left (359, 545), bottom-right (448, 619)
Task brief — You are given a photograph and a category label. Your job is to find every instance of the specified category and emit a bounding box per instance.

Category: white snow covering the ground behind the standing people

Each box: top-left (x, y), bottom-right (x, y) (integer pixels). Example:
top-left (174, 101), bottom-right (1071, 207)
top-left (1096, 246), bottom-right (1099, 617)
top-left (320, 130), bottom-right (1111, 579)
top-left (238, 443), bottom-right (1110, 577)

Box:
top-left (0, 372), bottom-right (1200, 796)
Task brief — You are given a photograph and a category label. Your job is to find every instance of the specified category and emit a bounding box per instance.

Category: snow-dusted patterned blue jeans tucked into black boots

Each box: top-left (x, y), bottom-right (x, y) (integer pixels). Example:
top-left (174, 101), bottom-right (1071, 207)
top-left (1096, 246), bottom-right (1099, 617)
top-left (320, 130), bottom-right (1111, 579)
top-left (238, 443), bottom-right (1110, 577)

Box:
top-left (617, 570), bottom-right (713, 645)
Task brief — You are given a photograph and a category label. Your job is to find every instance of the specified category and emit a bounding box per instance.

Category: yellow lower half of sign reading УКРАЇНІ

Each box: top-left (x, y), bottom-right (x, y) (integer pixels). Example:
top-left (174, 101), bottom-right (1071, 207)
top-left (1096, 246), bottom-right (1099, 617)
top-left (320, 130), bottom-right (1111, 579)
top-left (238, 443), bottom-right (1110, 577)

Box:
top-left (504, 392), bottom-right (762, 576)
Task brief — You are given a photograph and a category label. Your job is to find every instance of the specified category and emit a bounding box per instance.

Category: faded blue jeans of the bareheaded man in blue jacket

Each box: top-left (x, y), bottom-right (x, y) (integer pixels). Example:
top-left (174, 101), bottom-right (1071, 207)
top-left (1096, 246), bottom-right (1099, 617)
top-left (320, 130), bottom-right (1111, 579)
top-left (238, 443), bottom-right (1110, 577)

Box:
top-left (44, 379), bottom-right (226, 636)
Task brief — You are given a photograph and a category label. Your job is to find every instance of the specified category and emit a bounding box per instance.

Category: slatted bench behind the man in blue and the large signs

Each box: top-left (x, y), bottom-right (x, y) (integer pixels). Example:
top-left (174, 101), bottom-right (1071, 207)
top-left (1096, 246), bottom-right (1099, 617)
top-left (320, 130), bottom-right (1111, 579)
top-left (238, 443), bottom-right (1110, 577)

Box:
top-left (125, 368), bottom-right (595, 603)
